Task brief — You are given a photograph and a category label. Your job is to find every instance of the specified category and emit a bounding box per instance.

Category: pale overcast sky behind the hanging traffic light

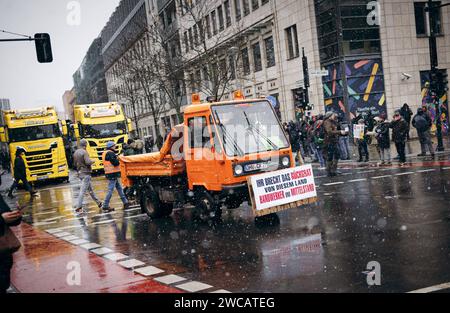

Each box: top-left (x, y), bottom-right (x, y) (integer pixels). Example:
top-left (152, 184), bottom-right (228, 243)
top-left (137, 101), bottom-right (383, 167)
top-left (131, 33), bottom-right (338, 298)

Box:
top-left (0, 0), bottom-right (120, 110)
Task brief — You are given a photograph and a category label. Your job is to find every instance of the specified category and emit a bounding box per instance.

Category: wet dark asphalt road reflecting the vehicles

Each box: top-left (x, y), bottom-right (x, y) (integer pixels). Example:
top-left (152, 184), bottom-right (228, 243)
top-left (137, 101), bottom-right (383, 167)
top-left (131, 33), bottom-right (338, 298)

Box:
top-left (3, 154), bottom-right (450, 292)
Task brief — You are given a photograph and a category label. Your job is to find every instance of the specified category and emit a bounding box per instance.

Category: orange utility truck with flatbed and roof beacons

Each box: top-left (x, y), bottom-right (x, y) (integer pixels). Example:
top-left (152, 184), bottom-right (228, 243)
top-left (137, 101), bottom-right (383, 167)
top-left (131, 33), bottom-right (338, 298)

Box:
top-left (120, 92), bottom-right (295, 220)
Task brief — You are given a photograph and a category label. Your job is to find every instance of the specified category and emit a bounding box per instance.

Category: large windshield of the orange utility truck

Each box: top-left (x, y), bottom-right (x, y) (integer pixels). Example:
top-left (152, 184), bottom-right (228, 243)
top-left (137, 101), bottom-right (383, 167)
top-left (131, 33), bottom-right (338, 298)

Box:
top-left (212, 101), bottom-right (289, 156)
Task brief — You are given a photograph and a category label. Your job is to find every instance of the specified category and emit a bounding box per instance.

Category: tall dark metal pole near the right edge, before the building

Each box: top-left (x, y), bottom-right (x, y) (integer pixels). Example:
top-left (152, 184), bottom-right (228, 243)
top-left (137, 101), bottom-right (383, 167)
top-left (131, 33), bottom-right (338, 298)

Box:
top-left (428, 0), bottom-right (444, 151)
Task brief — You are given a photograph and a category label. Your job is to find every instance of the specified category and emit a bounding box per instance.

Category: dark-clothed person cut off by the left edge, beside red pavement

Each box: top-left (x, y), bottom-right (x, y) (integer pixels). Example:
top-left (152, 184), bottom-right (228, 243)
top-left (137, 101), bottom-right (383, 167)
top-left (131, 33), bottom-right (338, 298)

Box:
top-left (0, 191), bottom-right (22, 294)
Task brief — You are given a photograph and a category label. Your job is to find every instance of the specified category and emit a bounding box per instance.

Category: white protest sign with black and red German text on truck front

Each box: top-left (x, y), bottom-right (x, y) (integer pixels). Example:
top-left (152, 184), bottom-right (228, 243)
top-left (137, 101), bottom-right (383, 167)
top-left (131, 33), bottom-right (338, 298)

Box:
top-left (249, 164), bottom-right (317, 216)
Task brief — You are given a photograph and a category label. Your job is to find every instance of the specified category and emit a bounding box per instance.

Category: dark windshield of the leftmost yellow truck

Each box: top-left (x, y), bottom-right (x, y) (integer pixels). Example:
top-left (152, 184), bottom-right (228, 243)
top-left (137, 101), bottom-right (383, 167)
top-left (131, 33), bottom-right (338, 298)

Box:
top-left (8, 124), bottom-right (61, 142)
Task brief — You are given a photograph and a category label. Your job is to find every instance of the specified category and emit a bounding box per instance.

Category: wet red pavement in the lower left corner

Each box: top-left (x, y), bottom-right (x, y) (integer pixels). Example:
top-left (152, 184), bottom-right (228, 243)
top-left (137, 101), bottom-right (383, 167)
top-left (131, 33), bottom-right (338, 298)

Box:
top-left (11, 223), bottom-right (182, 293)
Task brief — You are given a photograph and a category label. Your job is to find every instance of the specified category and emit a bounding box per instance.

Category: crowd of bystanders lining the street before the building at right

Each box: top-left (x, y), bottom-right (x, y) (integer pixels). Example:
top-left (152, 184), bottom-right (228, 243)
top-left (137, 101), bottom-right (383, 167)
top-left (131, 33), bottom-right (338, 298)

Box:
top-left (283, 103), bottom-right (435, 176)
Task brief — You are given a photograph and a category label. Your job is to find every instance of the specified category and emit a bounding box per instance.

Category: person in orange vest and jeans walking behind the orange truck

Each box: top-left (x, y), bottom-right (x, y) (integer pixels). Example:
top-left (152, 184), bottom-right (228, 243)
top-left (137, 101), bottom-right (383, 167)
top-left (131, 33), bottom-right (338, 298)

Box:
top-left (102, 141), bottom-right (129, 212)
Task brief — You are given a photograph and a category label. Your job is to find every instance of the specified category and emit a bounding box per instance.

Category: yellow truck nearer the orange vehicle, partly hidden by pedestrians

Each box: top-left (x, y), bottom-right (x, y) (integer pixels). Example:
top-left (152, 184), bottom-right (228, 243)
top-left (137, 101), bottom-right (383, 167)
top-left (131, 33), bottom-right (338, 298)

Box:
top-left (70, 102), bottom-right (132, 171)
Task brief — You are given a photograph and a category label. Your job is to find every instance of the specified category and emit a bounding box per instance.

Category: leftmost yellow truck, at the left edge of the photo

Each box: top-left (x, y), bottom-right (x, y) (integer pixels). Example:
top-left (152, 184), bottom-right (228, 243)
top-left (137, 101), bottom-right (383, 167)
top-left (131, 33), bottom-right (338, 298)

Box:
top-left (0, 107), bottom-right (69, 182)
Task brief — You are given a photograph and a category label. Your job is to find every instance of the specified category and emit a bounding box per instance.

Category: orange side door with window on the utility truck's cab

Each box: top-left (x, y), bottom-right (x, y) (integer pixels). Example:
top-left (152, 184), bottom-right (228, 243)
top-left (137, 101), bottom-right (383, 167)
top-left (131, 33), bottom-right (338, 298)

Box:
top-left (185, 115), bottom-right (220, 190)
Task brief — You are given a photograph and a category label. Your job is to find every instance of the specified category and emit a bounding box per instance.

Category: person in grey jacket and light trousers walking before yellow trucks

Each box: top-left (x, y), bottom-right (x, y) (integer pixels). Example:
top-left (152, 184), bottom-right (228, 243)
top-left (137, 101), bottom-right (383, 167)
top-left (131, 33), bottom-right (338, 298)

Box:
top-left (73, 139), bottom-right (102, 214)
